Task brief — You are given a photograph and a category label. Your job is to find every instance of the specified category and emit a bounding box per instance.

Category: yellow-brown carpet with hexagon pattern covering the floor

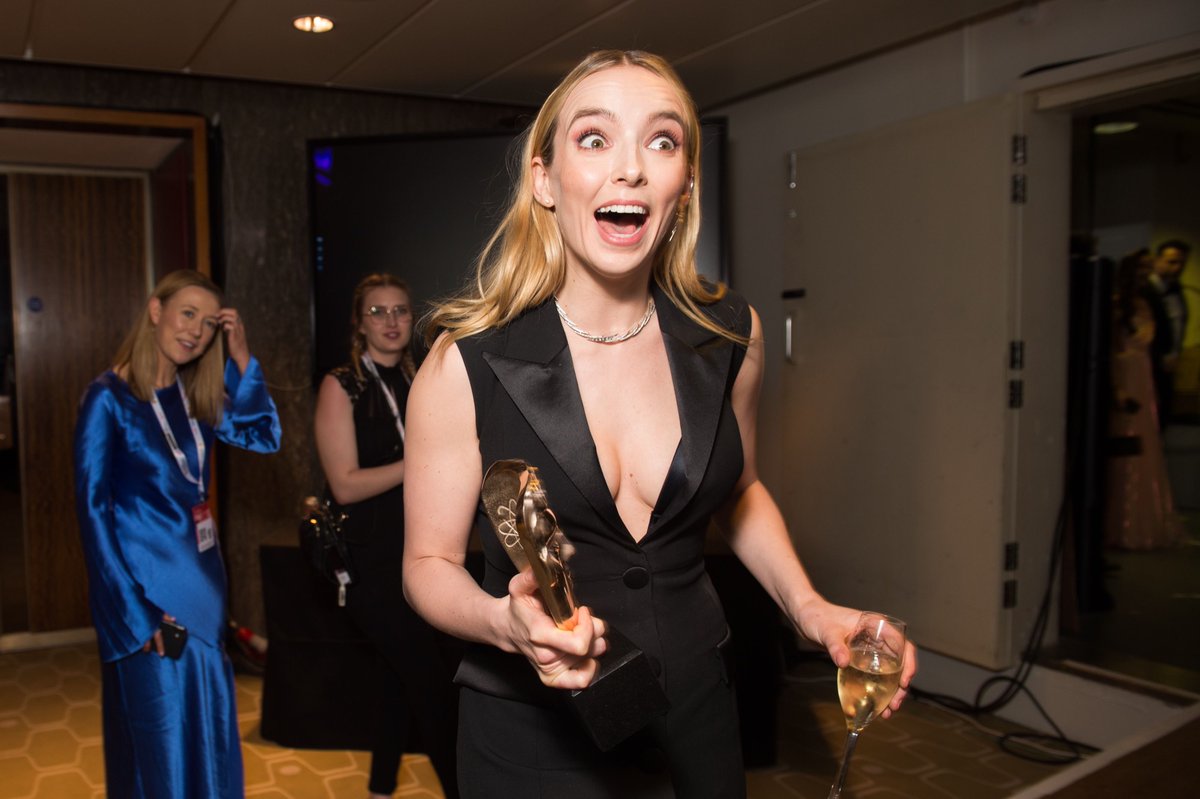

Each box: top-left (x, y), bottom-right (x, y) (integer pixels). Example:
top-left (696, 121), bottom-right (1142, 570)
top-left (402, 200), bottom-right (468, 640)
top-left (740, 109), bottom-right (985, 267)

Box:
top-left (0, 644), bottom-right (1080, 799)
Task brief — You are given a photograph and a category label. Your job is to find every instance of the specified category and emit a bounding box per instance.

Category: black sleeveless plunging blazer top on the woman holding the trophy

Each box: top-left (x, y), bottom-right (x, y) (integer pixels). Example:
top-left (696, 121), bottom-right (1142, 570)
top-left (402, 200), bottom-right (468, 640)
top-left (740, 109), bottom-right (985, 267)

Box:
top-left (457, 288), bottom-right (750, 704)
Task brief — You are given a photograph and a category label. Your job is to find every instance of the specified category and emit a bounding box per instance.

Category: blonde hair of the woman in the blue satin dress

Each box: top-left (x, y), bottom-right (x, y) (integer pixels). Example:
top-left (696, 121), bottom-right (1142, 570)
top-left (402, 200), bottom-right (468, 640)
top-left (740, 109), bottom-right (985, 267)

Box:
top-left (113, 269), bottom-right (224, 426)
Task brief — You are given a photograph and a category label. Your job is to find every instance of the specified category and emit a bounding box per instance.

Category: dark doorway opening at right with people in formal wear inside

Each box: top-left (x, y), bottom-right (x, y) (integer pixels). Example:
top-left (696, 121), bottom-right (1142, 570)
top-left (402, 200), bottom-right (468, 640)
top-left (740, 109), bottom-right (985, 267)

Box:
top-left (1057, 79), bottom-right (1200, 692)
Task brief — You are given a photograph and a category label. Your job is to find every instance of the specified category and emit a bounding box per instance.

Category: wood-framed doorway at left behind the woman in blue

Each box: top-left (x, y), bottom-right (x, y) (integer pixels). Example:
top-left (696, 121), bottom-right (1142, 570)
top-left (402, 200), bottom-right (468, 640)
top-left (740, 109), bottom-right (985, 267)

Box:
top-left (0, 103), bottom-right (210, 651)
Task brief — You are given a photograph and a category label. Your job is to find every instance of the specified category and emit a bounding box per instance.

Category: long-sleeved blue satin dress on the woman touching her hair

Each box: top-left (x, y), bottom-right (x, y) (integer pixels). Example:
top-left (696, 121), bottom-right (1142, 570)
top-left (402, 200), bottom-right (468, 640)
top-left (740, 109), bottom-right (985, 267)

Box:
top-left (74, 359), bottom-right (280, 799)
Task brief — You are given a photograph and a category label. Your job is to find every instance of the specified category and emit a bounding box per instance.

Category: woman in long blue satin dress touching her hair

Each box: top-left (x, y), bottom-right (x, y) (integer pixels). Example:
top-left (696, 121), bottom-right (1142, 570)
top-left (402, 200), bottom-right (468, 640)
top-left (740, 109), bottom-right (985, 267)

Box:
top-left (74, 270), bottom-right (280, 799)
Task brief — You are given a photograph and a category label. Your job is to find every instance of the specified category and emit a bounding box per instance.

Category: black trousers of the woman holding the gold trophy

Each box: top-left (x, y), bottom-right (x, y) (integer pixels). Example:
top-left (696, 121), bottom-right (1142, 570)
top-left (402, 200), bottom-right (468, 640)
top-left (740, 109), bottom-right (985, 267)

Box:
top-left (458, 633), bottom-right (746, 799)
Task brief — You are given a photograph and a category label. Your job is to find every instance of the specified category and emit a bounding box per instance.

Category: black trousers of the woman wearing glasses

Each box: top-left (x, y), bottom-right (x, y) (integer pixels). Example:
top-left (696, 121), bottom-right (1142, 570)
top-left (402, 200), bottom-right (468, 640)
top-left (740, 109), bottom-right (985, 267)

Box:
top-left (346, 537), bottom-right (462, 799)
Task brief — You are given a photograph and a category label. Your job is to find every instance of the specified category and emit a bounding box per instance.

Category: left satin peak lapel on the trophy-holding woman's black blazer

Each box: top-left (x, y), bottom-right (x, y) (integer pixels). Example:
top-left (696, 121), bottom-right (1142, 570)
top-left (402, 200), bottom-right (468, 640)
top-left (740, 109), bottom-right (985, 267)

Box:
top-left (484, 302), bottom-right (631, 540)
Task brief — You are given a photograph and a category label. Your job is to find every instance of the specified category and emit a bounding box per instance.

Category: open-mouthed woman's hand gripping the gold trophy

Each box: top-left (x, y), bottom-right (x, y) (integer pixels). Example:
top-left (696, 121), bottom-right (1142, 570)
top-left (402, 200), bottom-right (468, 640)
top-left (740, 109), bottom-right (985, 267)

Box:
top-left (508, 570), bottom-right (608, 690)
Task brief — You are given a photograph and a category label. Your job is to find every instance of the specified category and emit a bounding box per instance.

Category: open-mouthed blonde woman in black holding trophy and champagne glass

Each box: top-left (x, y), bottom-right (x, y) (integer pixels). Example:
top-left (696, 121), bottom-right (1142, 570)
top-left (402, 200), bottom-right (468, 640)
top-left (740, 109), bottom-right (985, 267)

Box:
top-left (404, 50), bottom-right (917, 799)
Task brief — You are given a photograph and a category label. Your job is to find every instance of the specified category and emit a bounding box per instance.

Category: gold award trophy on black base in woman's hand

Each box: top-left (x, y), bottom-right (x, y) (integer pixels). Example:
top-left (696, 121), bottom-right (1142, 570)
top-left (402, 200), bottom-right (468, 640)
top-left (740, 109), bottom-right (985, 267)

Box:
top-left (482, 461), bottom-right (668, 751)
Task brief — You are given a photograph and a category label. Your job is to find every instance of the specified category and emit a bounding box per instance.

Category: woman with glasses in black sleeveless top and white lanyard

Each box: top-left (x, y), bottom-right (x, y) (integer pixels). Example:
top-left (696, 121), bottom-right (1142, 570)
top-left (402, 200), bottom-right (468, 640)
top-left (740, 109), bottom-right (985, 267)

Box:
top-left (314, 274), bottom-right (458, 798)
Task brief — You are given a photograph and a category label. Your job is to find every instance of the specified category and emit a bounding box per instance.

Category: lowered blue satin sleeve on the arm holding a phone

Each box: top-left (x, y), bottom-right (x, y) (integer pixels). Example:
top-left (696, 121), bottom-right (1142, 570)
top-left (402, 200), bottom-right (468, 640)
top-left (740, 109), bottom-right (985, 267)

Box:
top-left (74, 380), bottom-right (162, 661)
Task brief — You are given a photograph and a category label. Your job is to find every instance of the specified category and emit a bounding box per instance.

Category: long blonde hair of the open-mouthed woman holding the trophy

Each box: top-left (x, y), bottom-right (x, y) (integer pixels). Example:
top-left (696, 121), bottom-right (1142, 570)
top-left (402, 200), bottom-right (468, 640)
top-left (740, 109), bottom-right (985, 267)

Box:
top-left (421, 50), bottom-right (744, 343)
